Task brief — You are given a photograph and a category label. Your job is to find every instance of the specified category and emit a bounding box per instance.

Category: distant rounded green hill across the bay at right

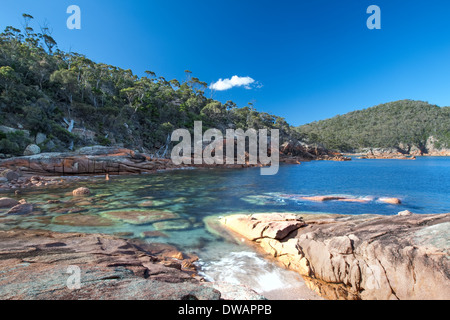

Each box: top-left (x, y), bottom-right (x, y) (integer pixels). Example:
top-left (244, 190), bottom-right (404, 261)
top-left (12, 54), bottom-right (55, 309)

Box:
top-left (296, 100), bottom-right (450, 153)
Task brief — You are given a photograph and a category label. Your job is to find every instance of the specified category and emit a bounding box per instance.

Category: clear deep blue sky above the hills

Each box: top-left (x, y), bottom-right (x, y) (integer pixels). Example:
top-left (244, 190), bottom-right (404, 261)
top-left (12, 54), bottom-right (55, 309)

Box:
top-left (0, 0), bottom-right (450, 125)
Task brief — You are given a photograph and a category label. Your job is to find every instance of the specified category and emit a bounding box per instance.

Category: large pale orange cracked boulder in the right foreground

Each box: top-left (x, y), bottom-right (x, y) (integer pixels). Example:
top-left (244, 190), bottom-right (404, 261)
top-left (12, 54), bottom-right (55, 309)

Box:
top-left (221, 213), bottom-right (450, 300)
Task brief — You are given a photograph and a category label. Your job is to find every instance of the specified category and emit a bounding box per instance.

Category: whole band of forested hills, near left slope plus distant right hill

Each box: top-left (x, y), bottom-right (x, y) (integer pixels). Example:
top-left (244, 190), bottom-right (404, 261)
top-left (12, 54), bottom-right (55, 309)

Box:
top-left (0, 14), bottom-right (450, 156)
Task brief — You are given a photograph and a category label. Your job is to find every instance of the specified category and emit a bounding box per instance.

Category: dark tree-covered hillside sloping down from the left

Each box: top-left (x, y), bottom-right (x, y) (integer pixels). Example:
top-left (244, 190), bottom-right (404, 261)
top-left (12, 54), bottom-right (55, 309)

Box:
top-left (0, 14), bottom-right (298, 155)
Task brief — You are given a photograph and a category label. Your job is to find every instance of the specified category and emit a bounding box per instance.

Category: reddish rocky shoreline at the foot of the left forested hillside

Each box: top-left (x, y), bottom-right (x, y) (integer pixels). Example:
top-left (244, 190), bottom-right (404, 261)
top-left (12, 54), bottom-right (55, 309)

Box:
top-left (0, 143), bottom-right (350, 190)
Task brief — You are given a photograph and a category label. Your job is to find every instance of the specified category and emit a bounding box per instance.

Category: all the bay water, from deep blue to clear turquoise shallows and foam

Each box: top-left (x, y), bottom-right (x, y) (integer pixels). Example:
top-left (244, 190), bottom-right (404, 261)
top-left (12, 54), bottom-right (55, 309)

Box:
top-left (0, 157), bottom-right (450, 293)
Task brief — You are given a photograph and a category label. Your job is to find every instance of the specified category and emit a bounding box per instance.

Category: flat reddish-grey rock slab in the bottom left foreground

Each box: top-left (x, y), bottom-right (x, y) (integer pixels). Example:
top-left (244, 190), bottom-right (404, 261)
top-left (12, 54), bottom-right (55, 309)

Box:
top-left (0, 230), bottom-right (221, 300)
